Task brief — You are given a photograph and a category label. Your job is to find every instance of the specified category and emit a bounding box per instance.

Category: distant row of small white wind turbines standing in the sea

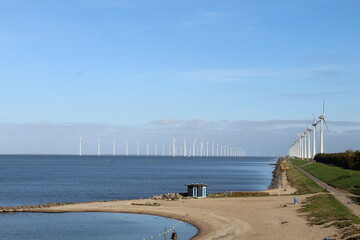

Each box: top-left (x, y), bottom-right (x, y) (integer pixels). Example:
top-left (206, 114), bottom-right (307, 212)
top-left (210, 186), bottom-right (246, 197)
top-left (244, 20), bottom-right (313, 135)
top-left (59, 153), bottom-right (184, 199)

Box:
top-left (79, 136), bottom-right (246, 157)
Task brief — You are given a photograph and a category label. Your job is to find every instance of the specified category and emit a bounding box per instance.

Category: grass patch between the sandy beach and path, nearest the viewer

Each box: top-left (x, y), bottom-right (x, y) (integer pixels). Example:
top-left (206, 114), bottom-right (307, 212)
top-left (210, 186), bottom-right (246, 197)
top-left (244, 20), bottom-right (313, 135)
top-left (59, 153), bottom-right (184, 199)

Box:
top-left (299, 194), bottom-right (360, 238)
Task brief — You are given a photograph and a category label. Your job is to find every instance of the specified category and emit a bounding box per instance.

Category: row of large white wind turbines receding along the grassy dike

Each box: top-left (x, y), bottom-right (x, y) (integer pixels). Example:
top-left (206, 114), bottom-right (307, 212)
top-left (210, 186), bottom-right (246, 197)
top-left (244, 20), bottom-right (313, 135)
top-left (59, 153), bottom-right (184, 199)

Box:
top-left (289, 101), bottom-right (329, 159)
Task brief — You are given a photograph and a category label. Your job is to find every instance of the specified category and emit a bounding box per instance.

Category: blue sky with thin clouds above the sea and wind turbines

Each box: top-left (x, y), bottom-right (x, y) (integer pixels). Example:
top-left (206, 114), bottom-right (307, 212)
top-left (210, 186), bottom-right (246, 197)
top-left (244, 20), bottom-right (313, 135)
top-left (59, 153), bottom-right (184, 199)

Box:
top-left (0, 0), bottom-right (360, 155)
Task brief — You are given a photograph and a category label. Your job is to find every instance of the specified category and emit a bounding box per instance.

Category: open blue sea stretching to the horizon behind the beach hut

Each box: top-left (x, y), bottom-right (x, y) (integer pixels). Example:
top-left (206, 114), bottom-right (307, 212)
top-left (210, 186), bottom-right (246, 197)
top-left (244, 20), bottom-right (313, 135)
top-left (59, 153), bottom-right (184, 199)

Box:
top-left (0, 155), bottom-right (277, 206)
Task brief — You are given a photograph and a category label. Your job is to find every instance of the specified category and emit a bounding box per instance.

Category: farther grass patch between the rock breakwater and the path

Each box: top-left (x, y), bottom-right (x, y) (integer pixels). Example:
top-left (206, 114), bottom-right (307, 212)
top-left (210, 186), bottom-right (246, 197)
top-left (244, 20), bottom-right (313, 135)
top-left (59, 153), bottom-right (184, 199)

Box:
top-left (286, 160), bottom-right (325, 194)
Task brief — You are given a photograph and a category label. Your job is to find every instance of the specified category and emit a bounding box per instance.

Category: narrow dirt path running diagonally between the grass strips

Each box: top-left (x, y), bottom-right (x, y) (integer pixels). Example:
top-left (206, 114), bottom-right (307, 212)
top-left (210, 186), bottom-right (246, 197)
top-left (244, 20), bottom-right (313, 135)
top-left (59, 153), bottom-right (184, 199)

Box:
top-left (293, 164), bottom-right (360, 217)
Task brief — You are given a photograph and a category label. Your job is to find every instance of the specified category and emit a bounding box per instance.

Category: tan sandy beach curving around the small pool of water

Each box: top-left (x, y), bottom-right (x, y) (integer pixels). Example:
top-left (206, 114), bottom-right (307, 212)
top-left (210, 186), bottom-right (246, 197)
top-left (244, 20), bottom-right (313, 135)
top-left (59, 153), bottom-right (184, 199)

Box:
top-left (36, 190), bottom-right (336, 240)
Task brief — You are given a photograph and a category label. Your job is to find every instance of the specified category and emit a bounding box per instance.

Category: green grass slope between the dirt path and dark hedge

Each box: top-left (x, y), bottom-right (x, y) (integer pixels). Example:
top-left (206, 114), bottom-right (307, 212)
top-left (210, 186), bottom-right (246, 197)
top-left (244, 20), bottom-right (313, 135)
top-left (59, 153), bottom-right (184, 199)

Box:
top-left (300, 160), bottom-right (360, 195)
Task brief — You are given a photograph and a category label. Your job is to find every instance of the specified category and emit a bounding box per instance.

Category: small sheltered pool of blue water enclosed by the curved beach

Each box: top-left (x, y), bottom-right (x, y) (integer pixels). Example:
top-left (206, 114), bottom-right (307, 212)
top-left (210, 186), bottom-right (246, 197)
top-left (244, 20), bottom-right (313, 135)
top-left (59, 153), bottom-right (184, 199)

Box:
top-left (0, 213), bottom-right (197, 240)
